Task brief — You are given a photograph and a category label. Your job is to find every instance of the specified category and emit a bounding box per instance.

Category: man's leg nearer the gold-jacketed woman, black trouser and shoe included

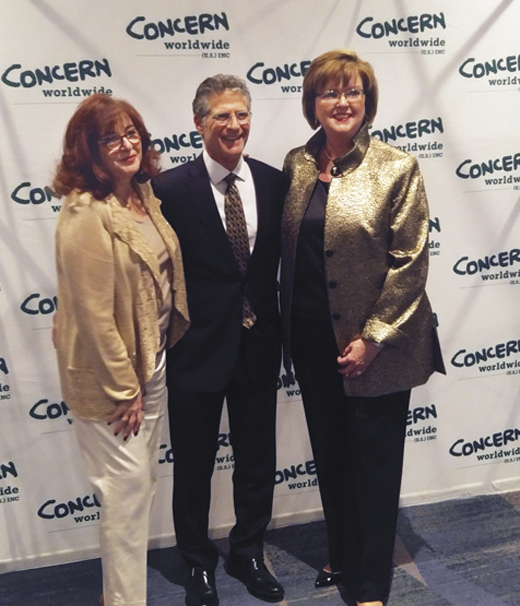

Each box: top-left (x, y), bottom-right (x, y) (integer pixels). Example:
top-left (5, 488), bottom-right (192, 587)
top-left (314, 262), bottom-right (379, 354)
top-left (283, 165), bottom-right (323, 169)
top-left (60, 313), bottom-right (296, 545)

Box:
top-left (226, 327), bottom-right (284, 601)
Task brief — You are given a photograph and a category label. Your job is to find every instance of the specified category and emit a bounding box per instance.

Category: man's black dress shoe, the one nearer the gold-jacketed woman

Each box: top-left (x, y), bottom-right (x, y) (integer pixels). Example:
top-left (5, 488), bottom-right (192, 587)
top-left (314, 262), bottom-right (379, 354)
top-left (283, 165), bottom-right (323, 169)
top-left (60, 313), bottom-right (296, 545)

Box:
top-left (225, 554), bottom-right (284, 602)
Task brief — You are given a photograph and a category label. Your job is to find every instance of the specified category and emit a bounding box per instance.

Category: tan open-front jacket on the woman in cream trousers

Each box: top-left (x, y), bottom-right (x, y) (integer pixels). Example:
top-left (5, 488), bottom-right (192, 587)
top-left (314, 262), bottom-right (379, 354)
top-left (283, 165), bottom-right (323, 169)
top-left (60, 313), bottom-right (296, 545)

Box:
top-left (56, 183), bottom-right (189, 420)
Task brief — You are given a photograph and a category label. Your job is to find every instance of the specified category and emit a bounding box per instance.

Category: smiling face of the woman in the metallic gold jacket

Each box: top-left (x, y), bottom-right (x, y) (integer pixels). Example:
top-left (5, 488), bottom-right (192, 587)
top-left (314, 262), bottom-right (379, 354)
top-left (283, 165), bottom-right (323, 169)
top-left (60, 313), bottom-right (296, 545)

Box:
top-left (315, 74), bottom-right (365, 141)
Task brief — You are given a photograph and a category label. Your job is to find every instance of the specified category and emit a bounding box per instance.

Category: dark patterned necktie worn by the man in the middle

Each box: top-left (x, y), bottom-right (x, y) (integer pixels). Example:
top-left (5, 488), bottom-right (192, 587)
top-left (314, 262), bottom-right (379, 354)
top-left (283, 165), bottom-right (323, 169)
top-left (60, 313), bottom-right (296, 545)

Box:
top-left (224, 173), bottom-right (256, 328)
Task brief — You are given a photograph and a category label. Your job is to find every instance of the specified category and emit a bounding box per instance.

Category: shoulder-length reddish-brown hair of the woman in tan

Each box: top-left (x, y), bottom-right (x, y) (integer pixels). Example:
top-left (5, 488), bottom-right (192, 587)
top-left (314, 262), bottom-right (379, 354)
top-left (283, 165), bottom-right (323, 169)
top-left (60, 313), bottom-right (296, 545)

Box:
top-left (53, 93), bottom-right (161, 200)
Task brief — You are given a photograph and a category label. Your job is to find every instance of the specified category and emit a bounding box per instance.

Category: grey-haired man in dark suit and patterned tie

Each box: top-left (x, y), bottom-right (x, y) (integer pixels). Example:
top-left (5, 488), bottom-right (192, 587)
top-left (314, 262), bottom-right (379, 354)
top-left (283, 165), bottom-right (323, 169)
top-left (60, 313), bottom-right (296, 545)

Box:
top-left (153, 74), bottom-right (286, 606)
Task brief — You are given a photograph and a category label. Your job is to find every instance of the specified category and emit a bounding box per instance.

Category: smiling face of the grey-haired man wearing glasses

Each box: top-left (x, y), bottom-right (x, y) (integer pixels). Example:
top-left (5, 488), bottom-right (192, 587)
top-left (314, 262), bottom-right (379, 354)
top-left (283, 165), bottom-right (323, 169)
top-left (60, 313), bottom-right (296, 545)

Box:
top-left (194, 90), bottom-right (251, 171)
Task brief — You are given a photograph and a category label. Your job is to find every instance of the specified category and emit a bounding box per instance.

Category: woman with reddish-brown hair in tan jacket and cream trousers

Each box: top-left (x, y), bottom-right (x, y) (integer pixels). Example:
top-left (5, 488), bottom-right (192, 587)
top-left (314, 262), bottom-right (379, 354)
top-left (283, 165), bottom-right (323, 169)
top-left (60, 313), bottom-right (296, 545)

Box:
top-left (54, 94), bottom-right (189, 606)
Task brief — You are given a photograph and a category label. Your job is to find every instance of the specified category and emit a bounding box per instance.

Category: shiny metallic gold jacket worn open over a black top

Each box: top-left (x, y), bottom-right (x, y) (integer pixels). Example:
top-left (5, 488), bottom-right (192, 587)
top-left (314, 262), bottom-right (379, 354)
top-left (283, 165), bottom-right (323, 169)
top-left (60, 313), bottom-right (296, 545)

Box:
top-left (282, 125), bottom-right (445, 396)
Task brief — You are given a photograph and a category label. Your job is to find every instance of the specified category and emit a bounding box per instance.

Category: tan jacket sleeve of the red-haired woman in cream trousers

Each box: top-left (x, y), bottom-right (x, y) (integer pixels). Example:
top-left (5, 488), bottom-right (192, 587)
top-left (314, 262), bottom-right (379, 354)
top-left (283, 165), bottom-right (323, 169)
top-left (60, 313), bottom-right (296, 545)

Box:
top-left (56, 202), bottom-right (140, 401)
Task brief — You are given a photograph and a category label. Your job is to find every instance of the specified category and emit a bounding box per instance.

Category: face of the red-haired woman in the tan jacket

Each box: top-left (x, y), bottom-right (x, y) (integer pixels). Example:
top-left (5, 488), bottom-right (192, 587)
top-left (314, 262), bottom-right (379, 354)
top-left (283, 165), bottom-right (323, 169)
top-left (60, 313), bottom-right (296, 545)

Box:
top-left (98, 114), bottom-right (143, 184)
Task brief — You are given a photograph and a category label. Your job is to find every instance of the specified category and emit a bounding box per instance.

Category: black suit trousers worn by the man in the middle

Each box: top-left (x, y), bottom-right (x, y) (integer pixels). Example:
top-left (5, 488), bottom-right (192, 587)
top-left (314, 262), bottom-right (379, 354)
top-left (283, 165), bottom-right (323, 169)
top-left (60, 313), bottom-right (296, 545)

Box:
top-left (168, 327), bottom-right (280, 570)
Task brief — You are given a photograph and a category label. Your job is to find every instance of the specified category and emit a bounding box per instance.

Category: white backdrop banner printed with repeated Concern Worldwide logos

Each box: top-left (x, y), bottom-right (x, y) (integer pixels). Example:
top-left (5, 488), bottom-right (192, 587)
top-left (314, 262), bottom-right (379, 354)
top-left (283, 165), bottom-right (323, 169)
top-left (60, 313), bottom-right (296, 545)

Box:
top-left (0, 0), bottom-right (520, 571)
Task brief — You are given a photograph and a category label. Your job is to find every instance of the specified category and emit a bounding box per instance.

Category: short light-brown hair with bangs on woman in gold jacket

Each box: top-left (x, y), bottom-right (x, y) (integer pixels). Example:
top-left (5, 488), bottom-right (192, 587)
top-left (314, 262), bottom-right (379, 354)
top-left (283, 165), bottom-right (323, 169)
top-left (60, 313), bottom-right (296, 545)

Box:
top-left (302, 48), bottom-right (379, 128)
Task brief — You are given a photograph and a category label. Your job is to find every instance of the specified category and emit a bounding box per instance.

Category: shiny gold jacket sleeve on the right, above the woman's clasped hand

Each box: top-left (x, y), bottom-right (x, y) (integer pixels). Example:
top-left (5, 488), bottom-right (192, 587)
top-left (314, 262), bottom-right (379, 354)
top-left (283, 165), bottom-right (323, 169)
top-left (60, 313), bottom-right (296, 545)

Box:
top-left (362, 158), bottom-right (429, 346)
